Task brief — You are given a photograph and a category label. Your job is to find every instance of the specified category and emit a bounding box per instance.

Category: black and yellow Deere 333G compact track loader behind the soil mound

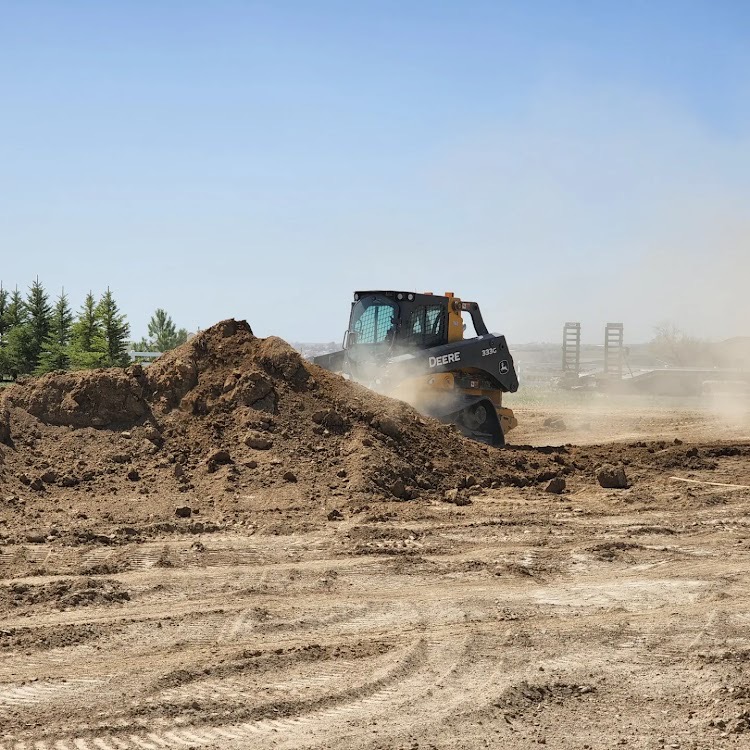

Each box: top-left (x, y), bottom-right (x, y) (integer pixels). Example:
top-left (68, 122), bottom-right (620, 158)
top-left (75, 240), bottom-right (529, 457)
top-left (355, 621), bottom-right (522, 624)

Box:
top-left (314, 291), bottom-right (518, 445)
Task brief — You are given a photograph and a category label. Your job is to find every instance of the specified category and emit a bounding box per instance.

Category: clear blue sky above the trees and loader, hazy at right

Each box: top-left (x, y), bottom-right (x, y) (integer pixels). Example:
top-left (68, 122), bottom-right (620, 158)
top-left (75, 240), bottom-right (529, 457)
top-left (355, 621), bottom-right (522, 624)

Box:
top-left (0, 0), bottom-right (750, 343)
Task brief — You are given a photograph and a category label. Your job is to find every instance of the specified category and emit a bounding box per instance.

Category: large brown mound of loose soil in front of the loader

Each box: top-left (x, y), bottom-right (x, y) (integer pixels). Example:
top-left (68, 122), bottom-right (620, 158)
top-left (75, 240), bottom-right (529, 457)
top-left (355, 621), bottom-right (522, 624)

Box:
top-left (0, 320), bottom-right (565, 543)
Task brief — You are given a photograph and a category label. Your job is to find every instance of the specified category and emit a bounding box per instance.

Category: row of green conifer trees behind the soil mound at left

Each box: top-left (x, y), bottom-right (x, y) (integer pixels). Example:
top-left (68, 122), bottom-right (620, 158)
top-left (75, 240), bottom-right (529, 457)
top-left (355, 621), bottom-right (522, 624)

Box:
top-left (0, 279), bottom-right (188, 380)
